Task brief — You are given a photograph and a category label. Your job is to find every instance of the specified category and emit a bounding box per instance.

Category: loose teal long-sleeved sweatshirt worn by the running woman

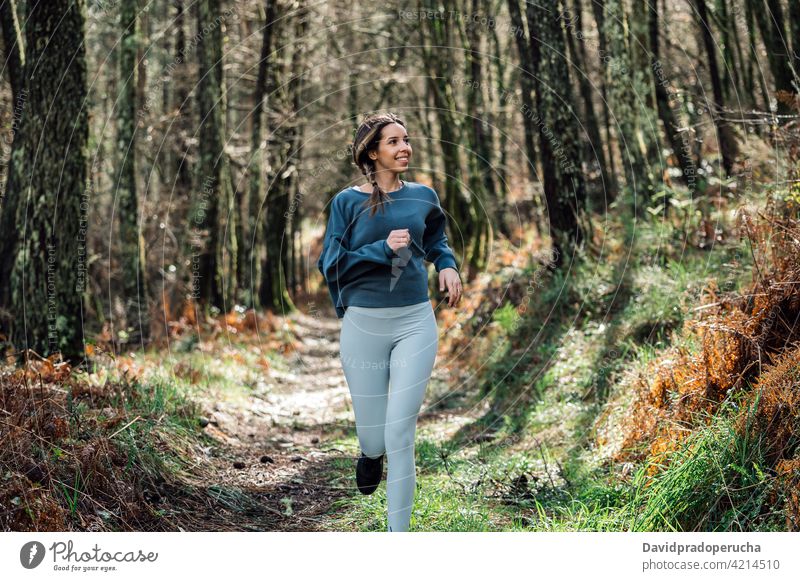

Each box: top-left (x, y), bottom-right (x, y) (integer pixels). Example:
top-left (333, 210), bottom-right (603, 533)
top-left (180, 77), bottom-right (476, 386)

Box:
top-left (317, 182), bottom-right (458, 319)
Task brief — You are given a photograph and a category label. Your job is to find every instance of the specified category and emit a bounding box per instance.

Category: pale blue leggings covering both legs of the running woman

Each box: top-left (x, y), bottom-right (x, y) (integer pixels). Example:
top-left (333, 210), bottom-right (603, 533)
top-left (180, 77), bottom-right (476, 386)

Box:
top-left (340, 301), bottom-right (439, 532)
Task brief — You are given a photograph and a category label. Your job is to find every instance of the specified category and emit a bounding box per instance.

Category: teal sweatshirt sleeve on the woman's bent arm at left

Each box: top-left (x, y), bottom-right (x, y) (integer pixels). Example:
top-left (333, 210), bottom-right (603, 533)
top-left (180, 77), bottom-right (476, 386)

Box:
top-left (317, 199), bottom-right (394, 283)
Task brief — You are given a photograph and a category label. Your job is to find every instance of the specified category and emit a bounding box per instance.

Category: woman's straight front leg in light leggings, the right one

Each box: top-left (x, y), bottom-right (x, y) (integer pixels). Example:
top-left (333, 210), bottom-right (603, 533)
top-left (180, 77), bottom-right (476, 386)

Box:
top-left (385, 303), bottom-right (439, 532)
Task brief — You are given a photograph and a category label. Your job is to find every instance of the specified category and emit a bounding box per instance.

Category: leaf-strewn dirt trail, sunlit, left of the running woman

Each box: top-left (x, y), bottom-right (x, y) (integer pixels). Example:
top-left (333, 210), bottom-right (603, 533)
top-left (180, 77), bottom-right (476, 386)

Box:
top-left (175, 312), bottom-right (352, 531)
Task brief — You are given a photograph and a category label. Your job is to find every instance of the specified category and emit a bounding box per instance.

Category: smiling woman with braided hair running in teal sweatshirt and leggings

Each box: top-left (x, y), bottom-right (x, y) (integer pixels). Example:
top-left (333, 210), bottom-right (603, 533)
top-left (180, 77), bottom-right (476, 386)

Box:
top-left (317, 113), bottom-right (462, 532)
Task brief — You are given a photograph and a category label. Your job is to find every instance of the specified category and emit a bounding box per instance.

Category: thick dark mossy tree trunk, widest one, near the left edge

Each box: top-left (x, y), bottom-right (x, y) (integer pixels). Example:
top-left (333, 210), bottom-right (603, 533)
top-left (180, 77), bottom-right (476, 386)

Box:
top-left (11, 0), bottom-right (91, 361)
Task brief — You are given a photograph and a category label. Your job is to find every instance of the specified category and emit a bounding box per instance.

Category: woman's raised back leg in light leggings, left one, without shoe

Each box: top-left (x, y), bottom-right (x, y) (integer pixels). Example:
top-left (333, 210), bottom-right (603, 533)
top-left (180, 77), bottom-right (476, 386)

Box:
top-left (339, 307), bottom-right (392, 458)
